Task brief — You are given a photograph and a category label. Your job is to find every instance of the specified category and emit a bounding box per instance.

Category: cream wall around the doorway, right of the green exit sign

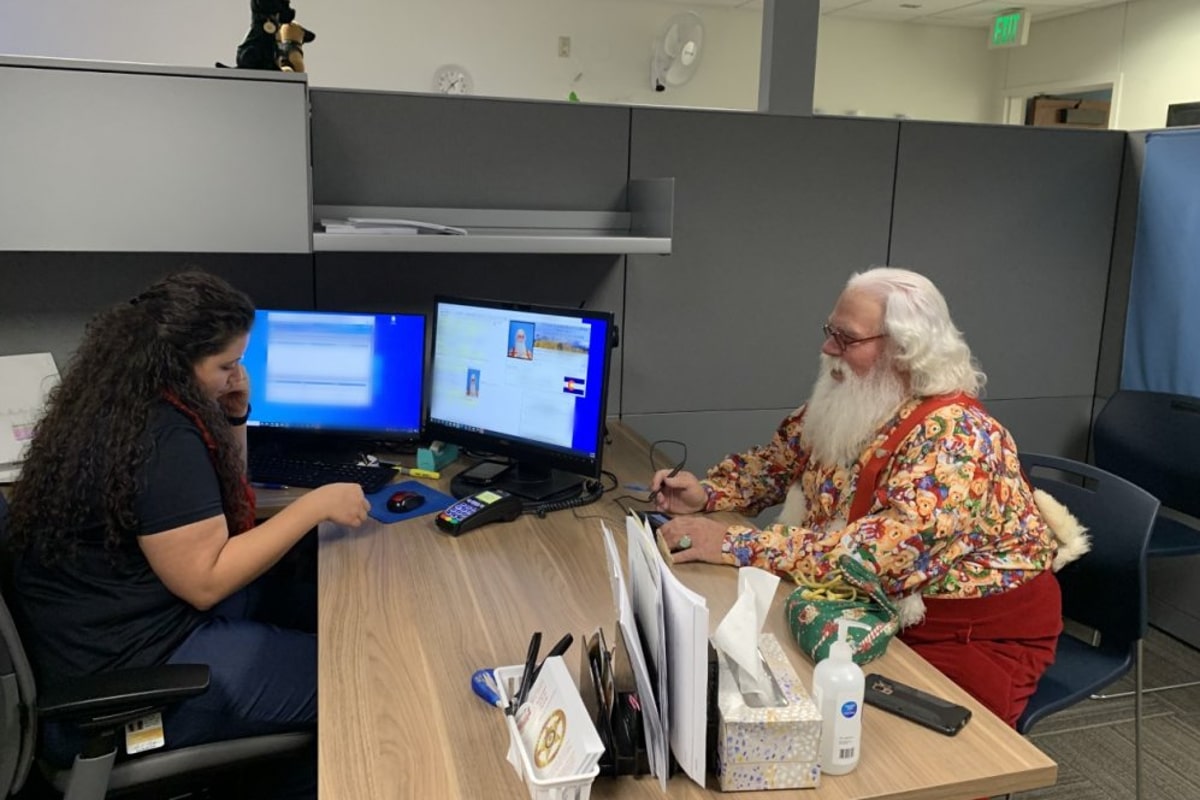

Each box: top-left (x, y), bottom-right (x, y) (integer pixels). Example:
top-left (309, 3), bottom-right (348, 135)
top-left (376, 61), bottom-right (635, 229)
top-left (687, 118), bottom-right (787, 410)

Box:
top-left (1003, 0), bottom-right (1200, 131)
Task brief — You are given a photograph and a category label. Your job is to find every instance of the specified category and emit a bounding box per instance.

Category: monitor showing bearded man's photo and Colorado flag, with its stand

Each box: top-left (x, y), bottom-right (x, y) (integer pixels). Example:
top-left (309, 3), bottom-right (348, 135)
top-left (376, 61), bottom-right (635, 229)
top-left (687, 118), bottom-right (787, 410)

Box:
top-left (425, 296), bottom-right (613, 501)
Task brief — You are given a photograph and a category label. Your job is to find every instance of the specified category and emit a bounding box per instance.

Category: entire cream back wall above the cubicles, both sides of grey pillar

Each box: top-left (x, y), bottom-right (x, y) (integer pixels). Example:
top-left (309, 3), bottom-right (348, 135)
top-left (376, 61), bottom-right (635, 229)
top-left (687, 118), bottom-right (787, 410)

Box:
top-left (0, 0), bottom-right (998, 121)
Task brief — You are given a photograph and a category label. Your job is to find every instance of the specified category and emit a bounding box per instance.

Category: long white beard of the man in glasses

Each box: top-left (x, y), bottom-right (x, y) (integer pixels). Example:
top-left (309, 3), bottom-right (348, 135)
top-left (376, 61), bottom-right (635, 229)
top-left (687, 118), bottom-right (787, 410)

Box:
top-left (800, 353), bottom-right (908, 467)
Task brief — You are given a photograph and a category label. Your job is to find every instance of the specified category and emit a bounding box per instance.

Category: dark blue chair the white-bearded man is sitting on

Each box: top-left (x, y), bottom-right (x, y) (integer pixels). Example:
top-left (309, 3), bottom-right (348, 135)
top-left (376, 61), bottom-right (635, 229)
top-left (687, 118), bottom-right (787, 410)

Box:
top-left (1016, 453), bottom-right (1158, 798)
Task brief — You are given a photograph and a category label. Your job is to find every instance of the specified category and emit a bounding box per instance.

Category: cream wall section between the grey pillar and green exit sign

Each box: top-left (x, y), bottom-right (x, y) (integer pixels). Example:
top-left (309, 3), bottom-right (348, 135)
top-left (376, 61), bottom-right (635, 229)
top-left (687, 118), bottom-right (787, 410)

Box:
top-left (812, 17), bottom-right (1004, 122)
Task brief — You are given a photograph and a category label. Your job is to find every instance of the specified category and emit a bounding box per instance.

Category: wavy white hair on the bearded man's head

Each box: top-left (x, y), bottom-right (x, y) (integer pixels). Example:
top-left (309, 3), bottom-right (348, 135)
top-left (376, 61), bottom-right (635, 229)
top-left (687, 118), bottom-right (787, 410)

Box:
top-left (846, 266), bottom-right (988, 397)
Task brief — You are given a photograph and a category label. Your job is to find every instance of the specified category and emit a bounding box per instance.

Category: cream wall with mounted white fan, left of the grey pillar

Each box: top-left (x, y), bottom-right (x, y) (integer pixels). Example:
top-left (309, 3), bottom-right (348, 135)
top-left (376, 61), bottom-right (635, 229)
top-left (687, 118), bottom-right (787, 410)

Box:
top-left (0, 0), bottom-right (762, 109)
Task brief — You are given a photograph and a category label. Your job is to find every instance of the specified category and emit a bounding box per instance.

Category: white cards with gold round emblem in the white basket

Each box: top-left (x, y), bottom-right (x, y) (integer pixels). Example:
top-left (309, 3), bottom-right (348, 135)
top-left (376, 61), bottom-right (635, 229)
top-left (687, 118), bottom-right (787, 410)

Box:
top-left (517, 656), bottom-right (604, 781)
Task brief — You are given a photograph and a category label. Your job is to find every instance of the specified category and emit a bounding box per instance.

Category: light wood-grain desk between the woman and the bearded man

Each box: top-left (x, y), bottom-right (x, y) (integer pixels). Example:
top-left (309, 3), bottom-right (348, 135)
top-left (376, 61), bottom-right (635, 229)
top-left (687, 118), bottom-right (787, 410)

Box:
top-left (319, 425), bottom-right (1057, 800)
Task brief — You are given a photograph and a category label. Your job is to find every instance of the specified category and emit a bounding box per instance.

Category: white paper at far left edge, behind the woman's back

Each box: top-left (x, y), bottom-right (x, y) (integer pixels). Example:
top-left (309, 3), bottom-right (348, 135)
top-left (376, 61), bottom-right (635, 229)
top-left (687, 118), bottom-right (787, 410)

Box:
top-left (0, 353), bottom-right (59, 482)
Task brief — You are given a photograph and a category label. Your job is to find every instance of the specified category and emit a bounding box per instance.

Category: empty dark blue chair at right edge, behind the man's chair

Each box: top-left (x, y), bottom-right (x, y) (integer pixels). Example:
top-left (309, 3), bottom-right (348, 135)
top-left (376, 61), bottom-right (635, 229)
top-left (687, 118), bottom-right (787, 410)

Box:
top-left (1092, 390), bottom-right (1200, 699)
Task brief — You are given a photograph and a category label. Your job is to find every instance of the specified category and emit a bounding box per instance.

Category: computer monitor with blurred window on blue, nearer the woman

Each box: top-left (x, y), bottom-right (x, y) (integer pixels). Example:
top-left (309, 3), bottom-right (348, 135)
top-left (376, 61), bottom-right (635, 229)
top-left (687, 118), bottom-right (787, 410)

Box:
top-left (242, 308), bottom-right (425, 452)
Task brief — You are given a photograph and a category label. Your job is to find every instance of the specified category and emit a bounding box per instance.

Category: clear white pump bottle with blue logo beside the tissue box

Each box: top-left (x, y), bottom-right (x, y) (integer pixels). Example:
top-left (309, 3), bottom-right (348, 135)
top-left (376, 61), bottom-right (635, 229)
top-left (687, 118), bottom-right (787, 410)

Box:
top-left (812, 619), bottom-right (870, 775)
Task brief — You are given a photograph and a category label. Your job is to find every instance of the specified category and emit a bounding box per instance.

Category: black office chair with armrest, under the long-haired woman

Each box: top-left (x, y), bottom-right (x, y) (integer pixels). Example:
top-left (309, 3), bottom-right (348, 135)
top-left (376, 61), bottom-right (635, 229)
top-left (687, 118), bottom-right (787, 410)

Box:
top-left (0, 495), bottom-right (316, 800)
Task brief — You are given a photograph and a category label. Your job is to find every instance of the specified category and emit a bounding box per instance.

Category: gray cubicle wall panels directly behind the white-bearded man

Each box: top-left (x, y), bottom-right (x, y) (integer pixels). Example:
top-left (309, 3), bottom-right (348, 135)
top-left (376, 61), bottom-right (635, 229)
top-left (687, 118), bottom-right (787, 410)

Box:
top-left (623, 110), bottom-right (1123, 469)
